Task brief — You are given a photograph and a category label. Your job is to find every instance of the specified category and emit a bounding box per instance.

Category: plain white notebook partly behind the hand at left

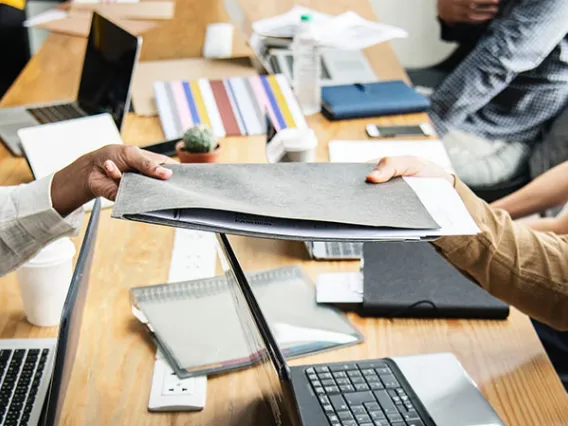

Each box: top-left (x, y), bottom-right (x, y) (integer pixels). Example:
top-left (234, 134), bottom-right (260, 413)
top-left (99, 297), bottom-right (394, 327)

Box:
top-left (18, 113), bottom-right (122, 210)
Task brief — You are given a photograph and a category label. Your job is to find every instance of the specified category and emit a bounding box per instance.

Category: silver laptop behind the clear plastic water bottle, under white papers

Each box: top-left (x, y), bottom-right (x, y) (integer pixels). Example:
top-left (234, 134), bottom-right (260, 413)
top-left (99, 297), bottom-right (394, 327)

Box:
top-left (269, 49), bottom-right (377, 86)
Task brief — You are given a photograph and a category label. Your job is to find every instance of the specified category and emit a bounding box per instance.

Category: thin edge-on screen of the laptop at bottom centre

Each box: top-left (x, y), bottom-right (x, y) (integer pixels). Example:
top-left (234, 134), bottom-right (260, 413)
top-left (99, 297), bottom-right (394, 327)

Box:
top-left (217, 234), bottom-right (300, 426)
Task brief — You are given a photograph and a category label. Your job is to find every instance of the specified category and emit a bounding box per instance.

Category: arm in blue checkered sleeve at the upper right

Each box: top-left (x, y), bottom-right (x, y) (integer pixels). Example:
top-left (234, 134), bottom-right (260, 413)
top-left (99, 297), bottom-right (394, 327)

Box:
top-left (430, 0), bottom-right (568, 137)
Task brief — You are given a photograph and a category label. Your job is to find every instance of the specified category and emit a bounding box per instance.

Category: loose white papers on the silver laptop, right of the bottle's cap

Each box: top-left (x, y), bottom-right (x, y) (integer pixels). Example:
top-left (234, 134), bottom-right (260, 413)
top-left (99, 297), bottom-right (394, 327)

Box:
top-left (314, 12), bottom-right (408, 50)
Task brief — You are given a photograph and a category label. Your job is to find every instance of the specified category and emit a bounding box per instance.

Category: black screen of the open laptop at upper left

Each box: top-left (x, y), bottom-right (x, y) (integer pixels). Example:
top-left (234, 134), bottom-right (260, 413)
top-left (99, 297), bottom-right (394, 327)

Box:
top-left (77, 12), bottom-right (140, 129)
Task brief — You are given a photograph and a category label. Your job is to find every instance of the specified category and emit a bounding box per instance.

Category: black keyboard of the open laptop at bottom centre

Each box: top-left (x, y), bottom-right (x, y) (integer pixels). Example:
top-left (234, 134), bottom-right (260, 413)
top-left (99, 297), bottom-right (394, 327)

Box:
top-left (306, 361), bottom-right (425, 426)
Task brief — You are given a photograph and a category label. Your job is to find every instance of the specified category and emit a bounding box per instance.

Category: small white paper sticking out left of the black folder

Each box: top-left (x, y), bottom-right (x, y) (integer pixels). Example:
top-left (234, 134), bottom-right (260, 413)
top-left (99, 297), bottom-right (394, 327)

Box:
top-left (316, 272), bottom-right (363, 303)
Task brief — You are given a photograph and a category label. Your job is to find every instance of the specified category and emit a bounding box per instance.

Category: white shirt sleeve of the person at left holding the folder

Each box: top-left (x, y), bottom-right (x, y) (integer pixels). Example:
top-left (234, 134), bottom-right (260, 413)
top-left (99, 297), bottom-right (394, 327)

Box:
top-left (0, 175), bottom-right (83, 276)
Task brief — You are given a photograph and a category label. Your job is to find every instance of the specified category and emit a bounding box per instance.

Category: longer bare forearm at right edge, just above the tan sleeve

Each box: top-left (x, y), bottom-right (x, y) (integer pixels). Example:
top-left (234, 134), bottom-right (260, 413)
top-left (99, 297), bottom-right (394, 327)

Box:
top-left (491, 162), bottom-right (568, 219)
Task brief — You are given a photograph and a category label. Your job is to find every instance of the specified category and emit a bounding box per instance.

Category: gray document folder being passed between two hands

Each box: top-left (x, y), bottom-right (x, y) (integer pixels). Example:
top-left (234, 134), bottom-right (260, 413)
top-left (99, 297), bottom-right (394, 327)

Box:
top-left (113, 163), bottom-right (440, 241)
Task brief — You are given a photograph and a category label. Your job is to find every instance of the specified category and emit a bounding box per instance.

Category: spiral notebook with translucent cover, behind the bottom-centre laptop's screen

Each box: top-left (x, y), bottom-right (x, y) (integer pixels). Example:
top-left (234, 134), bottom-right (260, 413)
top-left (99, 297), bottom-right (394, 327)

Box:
top-left (131, 266), bottom-right (363, 378)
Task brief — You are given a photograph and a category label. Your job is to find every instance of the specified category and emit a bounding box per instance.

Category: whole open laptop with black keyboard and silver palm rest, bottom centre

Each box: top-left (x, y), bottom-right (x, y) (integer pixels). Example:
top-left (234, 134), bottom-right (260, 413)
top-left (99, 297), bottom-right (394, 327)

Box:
top-left (217, 234), bottom-right (505, 426)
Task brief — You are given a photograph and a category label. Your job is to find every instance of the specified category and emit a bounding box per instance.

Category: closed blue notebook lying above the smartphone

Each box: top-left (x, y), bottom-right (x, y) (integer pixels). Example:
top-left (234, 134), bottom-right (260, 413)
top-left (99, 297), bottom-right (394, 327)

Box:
top-left (322, 81), bottom-right (430, 120)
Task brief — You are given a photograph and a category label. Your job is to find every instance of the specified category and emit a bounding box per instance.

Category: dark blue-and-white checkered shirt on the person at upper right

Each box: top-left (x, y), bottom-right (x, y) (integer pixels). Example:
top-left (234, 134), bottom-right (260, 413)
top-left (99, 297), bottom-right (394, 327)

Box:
top-left (430, 0), bottom-right (568, 142)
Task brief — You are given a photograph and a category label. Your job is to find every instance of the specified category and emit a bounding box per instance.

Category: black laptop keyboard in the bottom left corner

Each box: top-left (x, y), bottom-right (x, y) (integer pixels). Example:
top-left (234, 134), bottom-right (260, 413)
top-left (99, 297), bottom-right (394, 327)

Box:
top-left (0, 349), bottom-right (49, 426)
